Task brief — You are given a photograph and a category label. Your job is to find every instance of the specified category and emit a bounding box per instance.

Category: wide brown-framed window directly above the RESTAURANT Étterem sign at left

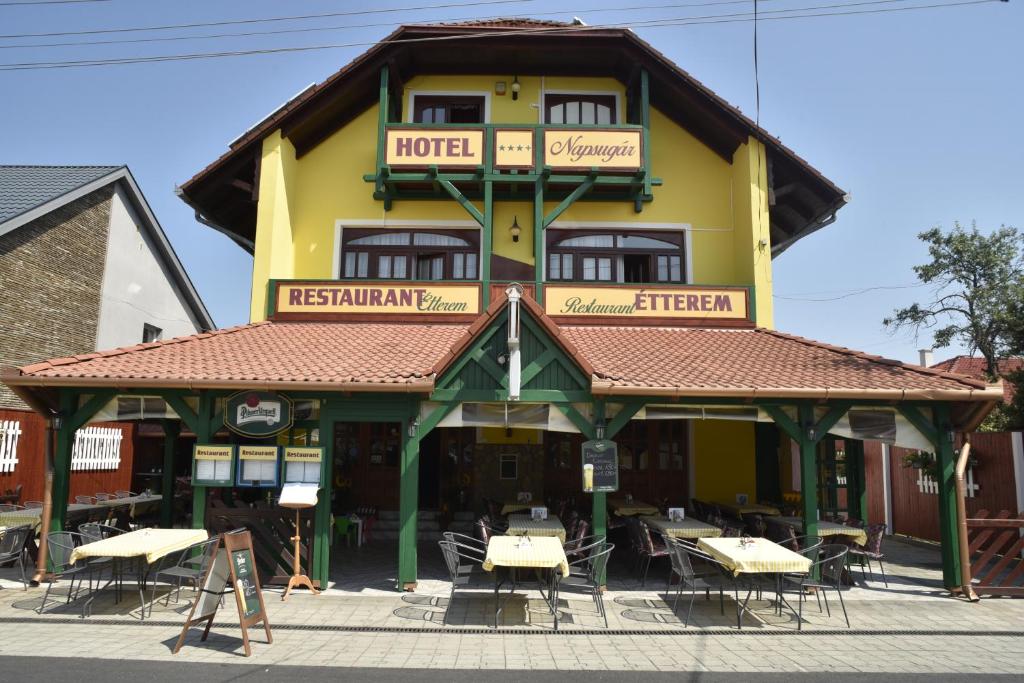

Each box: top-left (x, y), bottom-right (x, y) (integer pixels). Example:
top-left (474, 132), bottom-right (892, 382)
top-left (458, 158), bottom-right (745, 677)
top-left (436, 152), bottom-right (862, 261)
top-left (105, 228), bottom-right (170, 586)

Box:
top-left (341, 228), bottom-right (479, 280)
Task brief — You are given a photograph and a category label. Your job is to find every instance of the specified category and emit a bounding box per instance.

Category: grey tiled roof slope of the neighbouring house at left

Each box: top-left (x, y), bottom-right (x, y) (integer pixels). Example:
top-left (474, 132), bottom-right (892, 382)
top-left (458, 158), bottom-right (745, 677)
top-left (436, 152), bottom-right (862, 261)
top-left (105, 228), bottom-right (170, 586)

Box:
top-left (0, 166), bottom-right (122, 223)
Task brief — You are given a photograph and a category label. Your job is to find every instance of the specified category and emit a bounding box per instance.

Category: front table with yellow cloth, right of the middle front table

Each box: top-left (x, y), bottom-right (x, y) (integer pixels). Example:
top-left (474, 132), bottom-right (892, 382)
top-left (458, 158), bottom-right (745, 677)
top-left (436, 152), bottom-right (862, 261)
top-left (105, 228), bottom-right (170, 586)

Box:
top-left (697, 538), bottom-right (811, 629)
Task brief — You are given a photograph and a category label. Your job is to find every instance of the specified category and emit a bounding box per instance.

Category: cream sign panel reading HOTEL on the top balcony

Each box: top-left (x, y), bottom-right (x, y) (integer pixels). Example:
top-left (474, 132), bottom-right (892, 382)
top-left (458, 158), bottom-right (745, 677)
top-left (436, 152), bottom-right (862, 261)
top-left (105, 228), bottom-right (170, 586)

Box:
top-left (384, 128), bottom-right (483, 168)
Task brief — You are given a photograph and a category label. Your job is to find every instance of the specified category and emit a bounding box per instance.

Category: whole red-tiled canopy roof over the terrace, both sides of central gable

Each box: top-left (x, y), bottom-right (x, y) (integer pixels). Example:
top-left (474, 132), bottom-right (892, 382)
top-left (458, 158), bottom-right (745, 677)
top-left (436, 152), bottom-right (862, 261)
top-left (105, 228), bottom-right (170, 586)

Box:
top-left (2, 290), bottom-right (1002, 427)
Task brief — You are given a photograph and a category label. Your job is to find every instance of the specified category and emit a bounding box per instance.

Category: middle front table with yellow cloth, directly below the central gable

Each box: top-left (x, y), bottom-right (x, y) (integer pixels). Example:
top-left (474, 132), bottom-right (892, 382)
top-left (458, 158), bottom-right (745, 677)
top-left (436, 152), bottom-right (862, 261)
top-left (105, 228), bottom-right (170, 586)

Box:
top-left (483, 536), bottom-right (569, 631)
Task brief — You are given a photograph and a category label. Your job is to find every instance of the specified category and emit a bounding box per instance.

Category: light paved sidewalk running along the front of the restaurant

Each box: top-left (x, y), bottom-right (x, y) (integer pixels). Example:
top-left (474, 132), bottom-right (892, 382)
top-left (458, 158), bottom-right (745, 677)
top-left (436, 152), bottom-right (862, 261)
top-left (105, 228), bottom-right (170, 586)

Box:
top-left (0, 543), bottom-right (1024, 674)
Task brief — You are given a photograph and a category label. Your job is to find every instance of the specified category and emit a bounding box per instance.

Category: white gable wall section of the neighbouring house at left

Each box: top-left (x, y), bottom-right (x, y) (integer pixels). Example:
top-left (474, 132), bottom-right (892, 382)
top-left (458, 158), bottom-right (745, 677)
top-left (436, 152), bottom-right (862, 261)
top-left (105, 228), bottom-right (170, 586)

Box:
top-left (96, 182), bottom-right (200, 350)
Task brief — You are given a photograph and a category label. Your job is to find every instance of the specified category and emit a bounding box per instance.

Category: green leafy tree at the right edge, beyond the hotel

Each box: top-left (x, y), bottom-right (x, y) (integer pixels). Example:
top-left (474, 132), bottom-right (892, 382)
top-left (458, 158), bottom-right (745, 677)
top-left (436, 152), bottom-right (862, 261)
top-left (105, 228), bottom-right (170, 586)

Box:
top-left (884, 222), bottom-right (1024, 380)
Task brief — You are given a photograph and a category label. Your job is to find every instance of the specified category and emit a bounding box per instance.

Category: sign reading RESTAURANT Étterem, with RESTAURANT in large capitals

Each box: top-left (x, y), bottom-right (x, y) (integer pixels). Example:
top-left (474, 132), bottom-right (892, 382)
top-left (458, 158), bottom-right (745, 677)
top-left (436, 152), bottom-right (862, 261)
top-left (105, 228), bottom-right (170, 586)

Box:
top-left (274, 282), bottom-right (480, 317)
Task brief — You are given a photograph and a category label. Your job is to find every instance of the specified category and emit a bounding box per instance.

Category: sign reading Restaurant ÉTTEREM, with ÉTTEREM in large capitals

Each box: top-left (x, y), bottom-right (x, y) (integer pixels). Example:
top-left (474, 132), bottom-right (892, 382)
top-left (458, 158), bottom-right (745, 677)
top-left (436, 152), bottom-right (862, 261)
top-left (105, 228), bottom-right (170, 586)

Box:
top-left (544, 285), bottom-right (750, 321)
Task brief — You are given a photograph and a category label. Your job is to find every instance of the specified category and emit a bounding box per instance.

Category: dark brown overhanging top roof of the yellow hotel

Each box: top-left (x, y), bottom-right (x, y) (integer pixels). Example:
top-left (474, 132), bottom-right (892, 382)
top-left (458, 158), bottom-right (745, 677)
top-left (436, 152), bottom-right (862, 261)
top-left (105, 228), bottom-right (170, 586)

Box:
top-left (180, 19), bottom-right (846, 254)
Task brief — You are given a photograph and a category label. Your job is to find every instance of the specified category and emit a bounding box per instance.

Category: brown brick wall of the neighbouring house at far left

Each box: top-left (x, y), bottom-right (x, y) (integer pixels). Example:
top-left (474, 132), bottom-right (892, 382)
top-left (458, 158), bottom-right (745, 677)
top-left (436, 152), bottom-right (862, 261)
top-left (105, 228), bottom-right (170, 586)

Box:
top-left (0, 185), bottom-right (114, 409)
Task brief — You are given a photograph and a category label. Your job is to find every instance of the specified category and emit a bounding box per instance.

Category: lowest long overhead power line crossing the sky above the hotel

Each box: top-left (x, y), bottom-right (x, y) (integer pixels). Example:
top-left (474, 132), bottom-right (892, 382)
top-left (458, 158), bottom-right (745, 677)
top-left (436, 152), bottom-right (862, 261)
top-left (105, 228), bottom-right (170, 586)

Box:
top-left (0, 0), bottom-right (1005, 71)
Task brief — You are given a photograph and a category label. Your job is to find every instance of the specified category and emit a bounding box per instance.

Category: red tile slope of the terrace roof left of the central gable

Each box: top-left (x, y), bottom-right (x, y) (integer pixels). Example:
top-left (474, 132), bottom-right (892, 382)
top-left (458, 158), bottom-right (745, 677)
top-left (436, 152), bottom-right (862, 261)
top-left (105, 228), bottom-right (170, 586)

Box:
top-left (11, 323), bottom-right (466, 391)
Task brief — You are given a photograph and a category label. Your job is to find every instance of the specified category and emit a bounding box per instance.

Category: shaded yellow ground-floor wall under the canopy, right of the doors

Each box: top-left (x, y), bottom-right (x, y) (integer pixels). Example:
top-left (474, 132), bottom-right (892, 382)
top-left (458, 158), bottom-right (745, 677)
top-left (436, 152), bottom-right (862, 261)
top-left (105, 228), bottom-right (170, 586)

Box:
top-left (690, 420), bottom-right (757, 503)
